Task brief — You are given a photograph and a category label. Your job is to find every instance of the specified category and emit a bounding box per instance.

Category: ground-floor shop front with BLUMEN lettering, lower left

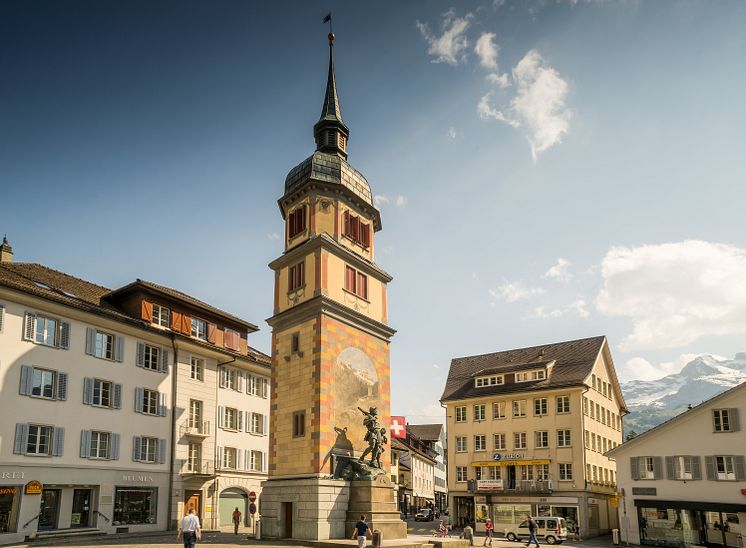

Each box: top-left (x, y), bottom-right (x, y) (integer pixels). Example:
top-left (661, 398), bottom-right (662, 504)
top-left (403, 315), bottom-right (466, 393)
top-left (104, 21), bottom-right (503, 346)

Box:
top-left (0, 466), bottom-right (168, 544)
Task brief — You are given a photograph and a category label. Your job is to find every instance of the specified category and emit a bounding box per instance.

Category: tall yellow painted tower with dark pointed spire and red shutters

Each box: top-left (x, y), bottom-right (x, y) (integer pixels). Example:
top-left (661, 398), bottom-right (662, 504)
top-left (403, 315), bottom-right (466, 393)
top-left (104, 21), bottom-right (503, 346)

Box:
top-left (261, 33), bottom-right (406, 540)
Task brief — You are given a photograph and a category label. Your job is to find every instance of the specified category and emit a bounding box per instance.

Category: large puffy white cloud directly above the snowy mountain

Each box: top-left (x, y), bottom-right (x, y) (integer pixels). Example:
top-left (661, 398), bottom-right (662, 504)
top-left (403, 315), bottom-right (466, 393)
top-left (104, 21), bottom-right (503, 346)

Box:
top-left (596, 240), bottom-right (746, 351)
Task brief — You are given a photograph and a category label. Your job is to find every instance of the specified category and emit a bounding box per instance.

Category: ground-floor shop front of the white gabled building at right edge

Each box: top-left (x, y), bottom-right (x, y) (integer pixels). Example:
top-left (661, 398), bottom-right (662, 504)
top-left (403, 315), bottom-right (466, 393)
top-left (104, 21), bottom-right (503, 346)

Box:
top-left (634, 499), bottom-right (746, 548)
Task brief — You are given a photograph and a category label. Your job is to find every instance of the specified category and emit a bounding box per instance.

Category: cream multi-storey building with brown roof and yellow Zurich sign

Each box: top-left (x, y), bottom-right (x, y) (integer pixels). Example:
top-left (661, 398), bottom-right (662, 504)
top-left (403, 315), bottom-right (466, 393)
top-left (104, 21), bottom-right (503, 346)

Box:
top-left (441, 337), bottom-right (626, 537)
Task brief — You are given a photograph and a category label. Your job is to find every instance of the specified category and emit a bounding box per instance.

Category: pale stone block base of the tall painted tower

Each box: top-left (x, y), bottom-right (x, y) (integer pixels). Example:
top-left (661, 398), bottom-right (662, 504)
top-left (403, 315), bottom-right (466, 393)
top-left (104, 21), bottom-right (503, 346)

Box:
top-left (260, 477), bottom-right (350, 540)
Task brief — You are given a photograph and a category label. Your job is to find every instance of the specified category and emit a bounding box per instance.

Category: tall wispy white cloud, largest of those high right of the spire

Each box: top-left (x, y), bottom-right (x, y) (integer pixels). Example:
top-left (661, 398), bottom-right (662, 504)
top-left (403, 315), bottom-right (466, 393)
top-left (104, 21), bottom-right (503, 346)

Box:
top-left (477, 49), bottom-right (572, 160)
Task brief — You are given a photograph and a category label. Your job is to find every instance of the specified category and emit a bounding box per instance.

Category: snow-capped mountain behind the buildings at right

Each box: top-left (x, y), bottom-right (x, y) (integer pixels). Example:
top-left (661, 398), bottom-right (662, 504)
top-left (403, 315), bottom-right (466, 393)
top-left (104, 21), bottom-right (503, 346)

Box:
top-left (622, 352), bottom-right (746, 435)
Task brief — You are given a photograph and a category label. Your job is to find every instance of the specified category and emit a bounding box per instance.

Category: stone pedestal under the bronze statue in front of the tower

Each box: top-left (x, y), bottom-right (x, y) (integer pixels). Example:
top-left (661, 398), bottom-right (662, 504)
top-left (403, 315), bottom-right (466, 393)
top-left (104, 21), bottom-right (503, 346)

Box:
top-left (346, 475), bottom-right (407, 541)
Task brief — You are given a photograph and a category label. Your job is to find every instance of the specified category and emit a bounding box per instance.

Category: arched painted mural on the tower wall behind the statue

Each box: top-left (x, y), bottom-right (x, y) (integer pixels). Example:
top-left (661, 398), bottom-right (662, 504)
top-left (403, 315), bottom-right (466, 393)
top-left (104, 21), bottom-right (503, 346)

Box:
top-left (333, 347), bottom-right (383, 454)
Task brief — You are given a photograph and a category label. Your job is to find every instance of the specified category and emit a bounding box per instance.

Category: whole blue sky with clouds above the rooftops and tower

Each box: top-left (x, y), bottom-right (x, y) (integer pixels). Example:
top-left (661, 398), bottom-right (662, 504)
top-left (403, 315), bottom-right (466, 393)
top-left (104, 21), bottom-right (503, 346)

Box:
top-left (0, 0), bottom-right (746, 422)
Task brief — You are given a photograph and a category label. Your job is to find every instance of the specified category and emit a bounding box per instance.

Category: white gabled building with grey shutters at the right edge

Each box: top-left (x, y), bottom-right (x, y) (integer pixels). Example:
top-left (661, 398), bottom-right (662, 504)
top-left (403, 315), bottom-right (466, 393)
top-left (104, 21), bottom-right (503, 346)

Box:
top-left (607, 383), bottom-right (746, 548)
